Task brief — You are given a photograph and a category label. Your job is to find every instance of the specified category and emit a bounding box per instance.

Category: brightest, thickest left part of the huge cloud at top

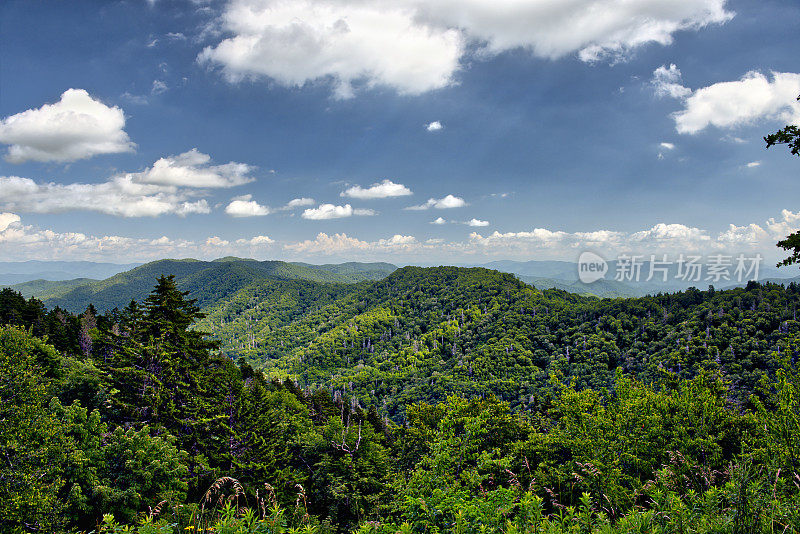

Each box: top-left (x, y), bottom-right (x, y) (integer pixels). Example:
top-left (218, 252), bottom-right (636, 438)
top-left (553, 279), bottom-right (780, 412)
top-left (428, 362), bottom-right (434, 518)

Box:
top-left (198, 0), bottom-right (464, 98)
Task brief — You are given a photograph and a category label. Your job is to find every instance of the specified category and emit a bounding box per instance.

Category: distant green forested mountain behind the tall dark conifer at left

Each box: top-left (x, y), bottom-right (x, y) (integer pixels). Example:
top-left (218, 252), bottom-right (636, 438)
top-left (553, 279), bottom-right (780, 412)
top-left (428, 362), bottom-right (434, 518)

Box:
top-left (27, 258), bottom-right (396, 312)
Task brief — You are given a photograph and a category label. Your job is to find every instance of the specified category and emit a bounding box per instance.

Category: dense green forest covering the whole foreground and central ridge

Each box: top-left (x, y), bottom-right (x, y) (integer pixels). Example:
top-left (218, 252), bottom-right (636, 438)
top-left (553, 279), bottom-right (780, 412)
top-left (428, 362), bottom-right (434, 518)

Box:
top-left (0, 268), bottom-right (800, 533)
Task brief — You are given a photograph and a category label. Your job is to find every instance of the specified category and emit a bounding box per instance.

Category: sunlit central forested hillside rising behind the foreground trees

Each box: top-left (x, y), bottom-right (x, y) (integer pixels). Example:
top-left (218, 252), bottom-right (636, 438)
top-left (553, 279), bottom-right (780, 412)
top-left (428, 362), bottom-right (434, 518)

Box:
top-left (199, 267), bottom-right (800, 418)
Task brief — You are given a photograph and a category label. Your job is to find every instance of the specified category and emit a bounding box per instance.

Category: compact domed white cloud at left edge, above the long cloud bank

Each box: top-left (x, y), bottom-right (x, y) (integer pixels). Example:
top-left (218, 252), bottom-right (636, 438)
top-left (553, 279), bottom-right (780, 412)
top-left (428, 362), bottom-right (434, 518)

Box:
top-left (0, 89), bottom-right (135, 163)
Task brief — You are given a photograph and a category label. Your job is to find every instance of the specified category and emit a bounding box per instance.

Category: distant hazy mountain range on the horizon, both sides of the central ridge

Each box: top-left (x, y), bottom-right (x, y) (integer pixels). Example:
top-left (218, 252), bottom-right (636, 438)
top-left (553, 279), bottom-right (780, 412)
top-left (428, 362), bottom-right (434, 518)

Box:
top-left (6, 257), bottom-right (800, 312)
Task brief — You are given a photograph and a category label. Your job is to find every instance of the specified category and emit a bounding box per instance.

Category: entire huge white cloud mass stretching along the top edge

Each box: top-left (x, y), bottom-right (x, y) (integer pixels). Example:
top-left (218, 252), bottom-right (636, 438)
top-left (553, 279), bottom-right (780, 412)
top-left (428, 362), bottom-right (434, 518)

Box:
top-left (198, 0), bottom-right (733, 98)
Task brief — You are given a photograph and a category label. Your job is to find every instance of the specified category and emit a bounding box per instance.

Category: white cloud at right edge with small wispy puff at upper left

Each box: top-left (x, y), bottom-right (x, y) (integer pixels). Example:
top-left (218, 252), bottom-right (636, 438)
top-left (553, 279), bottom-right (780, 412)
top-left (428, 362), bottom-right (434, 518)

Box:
top-left (653, 65), bottom-right (800, 134)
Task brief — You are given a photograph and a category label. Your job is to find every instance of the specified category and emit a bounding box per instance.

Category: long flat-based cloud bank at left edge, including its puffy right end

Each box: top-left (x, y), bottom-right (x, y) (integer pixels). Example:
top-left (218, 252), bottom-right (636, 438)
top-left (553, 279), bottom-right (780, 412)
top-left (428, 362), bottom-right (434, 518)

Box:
top-left (0, 149), bottom-right (253, 217)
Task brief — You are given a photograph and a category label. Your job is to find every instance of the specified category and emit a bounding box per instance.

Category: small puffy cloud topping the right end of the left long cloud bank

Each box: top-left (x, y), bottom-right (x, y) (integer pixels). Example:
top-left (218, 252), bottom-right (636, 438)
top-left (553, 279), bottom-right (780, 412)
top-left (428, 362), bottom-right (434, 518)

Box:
top-left (132, 148), bottom-right (255, 188)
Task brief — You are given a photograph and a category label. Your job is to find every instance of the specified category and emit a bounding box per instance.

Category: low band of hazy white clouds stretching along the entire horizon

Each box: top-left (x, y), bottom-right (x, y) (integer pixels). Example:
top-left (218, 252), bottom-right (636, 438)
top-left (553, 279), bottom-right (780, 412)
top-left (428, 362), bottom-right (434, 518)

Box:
top-left (6, 210), bottom-right (800, 262)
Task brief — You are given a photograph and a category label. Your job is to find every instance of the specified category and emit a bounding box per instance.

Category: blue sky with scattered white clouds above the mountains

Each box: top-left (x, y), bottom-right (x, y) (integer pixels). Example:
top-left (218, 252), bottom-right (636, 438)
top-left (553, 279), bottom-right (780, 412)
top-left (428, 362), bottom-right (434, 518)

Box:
top-left (0, 0), bottom-right (800, 265)
